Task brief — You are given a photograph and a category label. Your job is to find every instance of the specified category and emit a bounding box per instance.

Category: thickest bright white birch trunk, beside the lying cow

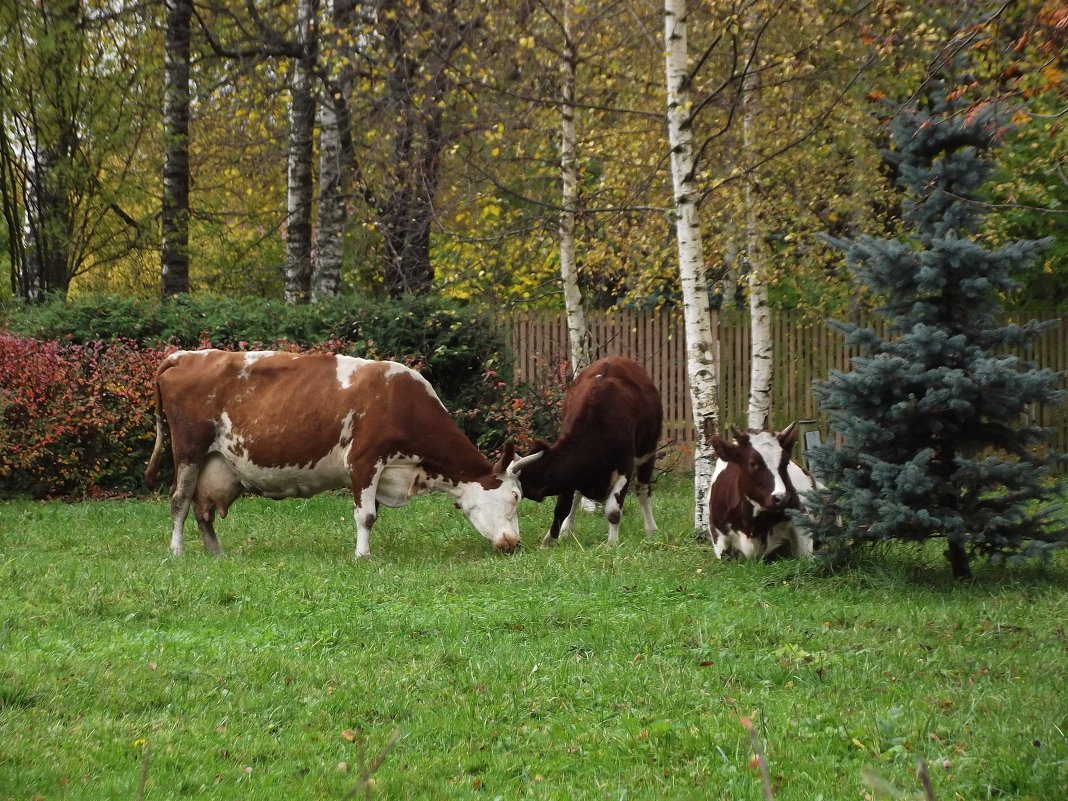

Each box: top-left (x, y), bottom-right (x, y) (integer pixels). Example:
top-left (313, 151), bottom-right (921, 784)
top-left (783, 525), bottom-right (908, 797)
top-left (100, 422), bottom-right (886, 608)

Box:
top-left (664, 0), bottom-right (719, 531)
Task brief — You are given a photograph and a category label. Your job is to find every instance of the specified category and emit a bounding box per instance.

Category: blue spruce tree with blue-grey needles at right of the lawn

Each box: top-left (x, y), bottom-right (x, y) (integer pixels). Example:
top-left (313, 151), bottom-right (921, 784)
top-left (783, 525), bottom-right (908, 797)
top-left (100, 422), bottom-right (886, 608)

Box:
top-left (802, 86), bottom-right (1068, 578)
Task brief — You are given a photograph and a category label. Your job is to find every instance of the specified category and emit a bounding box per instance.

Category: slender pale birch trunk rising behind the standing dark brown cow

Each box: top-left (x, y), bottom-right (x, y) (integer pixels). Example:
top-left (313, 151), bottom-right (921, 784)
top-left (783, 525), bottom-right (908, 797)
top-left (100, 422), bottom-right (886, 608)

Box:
top-left (560, 0), bottom-right (593, 374)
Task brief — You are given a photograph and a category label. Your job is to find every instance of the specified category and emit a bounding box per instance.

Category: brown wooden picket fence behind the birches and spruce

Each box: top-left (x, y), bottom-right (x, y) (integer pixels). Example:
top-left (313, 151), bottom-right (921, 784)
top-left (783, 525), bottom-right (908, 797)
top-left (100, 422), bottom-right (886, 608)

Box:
top-left (506, 311), bottom-right (1068, 467)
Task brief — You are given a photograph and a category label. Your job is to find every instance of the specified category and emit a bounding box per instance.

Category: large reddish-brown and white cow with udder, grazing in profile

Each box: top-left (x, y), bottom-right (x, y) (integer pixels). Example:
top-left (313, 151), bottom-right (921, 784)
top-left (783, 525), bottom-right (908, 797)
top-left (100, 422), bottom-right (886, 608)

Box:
top-left (145, 350), bottom-right (521, 556)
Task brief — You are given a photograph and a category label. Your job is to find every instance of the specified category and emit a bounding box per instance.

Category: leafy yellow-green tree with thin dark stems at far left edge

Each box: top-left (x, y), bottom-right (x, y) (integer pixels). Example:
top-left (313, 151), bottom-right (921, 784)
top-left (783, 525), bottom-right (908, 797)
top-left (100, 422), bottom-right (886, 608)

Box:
top-left (0, 0), bottom-right (158, 300)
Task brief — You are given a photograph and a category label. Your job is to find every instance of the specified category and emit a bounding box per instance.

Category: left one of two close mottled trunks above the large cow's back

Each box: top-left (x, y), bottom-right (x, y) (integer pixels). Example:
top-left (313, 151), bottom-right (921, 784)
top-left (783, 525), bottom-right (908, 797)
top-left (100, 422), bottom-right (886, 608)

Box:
top-left (285, 0), bottom-right (319, 304)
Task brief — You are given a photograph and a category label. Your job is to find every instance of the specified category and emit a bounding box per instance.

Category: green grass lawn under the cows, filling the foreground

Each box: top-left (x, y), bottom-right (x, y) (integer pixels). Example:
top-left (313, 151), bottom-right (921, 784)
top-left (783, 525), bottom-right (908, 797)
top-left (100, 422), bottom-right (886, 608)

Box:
top-left (0, 476), bottom-right (1068, 801)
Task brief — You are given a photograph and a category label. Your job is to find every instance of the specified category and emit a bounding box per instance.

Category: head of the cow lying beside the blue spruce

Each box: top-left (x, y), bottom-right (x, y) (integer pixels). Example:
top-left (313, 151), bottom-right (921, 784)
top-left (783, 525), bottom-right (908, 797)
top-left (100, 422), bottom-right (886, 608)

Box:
top-left (712, 423), bottom-right (798, 511)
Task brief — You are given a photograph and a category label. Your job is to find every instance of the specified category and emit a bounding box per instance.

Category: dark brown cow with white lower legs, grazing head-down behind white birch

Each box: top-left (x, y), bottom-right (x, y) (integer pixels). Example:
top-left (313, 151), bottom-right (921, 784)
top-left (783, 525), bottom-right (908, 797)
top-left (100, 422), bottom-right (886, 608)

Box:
top-left (517, 358), bottom-right (663, 546)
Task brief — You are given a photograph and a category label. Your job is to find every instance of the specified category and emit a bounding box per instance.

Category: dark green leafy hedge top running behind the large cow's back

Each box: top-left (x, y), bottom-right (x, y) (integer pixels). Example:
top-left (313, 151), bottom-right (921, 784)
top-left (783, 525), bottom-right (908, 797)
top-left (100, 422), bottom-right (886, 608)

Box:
top-left (0, 295), bottom-right (512, 429)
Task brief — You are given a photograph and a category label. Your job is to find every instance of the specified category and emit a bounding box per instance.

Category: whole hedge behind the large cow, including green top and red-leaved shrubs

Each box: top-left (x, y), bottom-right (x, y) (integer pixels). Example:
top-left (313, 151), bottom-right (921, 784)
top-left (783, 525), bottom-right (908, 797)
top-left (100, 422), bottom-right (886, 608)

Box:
top-left (0, 296), bottom-right (564, 497)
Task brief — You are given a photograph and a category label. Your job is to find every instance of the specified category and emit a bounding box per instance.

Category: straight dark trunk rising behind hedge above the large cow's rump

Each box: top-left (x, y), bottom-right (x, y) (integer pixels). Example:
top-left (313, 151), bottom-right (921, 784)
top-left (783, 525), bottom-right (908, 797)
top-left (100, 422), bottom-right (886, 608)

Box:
top-left (160, 0), bottom-right (193, 298)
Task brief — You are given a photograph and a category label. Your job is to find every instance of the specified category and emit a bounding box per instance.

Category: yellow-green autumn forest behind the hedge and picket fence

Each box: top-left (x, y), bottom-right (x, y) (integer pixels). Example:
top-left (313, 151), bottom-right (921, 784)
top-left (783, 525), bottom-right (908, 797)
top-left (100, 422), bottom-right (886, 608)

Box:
top-left (0, 0), bottom-right (1068, 317)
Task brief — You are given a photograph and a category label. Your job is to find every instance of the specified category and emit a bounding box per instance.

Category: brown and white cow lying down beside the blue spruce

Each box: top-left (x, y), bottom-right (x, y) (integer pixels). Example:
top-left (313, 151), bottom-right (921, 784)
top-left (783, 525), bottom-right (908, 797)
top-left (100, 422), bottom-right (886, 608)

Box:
top-left (708, 423), bottom-right (816, 559)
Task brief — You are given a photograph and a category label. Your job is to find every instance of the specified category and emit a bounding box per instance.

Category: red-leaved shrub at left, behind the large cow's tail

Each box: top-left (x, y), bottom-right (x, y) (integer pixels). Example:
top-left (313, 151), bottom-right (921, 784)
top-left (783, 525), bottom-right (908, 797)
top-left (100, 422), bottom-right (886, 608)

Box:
top-left (0, 332), bottom-right (173, 498)
